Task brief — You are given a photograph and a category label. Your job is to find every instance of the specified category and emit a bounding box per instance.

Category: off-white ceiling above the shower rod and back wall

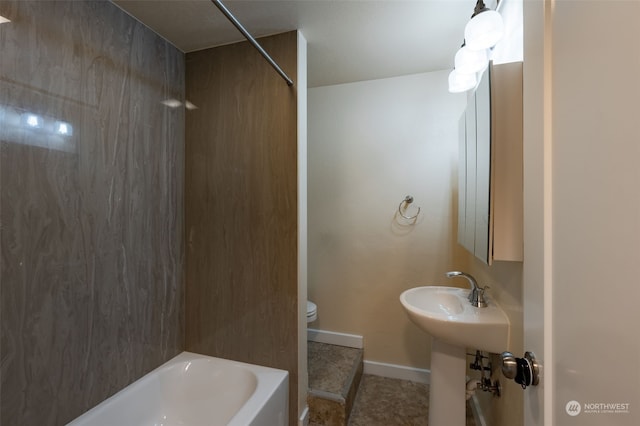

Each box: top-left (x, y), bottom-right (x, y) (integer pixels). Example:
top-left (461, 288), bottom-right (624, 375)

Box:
top-left (112, 0), bottom-right (475, 87)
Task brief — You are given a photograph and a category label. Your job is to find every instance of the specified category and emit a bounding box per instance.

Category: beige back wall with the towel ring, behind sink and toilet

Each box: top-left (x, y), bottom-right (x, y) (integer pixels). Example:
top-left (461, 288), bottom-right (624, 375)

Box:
top-left (308, 71), bottom-right (466, 368)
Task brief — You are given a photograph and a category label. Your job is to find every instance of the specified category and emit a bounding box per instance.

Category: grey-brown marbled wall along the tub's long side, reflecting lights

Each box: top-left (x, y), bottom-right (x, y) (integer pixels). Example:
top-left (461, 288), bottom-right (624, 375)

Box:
top-left (0, 0), bottom-right (184, 426)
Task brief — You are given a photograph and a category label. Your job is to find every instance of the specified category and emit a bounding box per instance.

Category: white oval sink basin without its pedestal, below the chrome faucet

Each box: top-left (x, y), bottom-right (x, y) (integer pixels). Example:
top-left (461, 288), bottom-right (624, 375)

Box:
top-left (400, 286), bottom-right (509, 353)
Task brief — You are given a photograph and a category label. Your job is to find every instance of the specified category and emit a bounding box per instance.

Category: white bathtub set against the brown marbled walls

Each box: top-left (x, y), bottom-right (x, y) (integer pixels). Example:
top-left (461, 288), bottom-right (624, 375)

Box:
top-left (68, 352), bottom-right (289, 426)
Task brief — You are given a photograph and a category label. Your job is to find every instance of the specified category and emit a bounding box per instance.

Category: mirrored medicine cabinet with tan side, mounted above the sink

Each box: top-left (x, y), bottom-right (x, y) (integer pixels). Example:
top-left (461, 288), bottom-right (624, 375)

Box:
top-left (458, 62), bottom-right (523, 265)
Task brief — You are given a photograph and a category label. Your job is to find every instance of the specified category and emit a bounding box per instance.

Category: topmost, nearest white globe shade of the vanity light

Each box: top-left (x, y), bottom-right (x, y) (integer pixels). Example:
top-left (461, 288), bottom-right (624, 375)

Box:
top-left (464, 0), bottom-right (504, 50)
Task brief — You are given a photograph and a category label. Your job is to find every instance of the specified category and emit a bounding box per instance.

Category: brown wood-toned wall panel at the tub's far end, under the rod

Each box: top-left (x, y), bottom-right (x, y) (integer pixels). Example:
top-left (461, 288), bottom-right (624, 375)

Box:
top-left (185, 32), bottom-right (298, 425)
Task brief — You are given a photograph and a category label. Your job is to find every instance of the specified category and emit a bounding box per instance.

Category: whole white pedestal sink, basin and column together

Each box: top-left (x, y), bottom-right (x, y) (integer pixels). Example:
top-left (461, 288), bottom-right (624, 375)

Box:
top-left (400, 286), bottom-right (510, 426)
